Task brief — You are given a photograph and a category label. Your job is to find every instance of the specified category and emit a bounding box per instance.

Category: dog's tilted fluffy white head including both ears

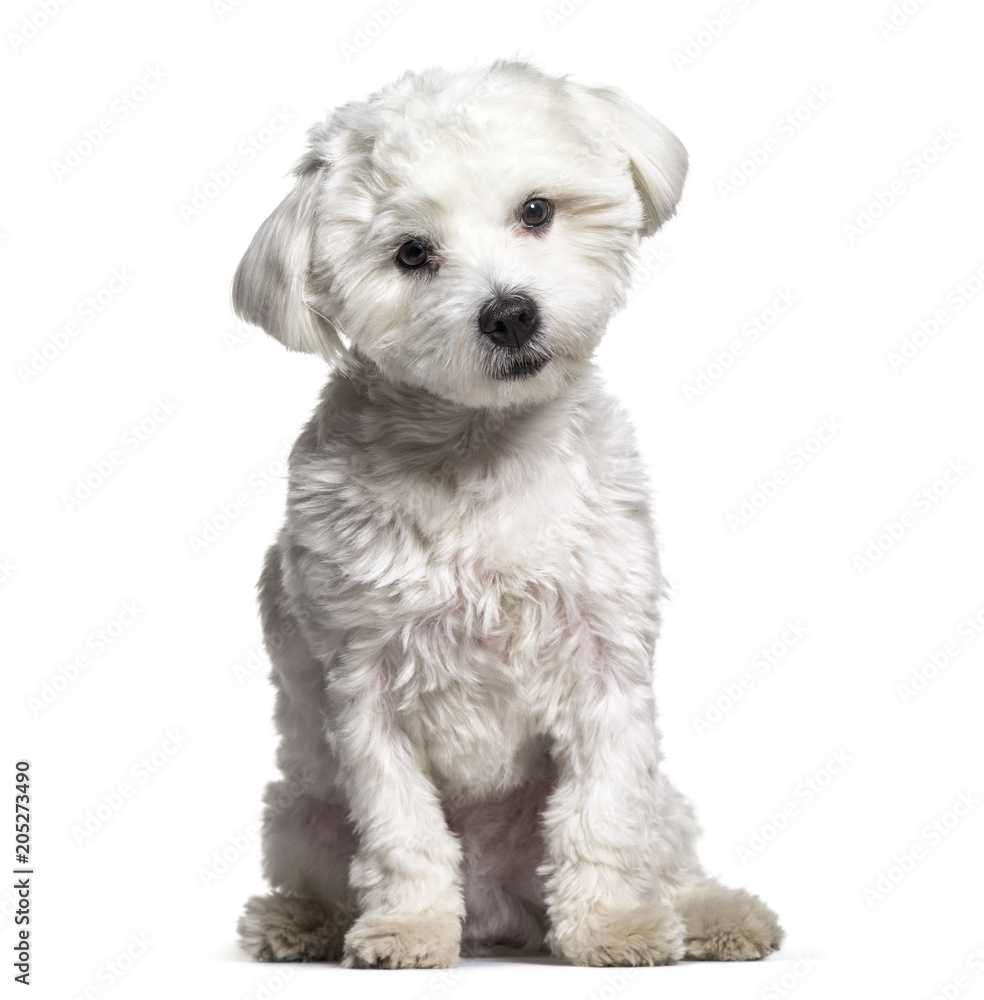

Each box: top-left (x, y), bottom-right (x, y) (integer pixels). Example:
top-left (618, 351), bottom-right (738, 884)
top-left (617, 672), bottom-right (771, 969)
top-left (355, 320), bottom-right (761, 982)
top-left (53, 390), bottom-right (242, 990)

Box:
top-left (234, 63), bottom-right (686, 406)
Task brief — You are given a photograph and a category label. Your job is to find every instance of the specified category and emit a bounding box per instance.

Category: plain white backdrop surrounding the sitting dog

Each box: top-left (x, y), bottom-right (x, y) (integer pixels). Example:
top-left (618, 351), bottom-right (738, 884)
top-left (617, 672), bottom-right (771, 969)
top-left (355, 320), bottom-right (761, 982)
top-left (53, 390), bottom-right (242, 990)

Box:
top-left (0, 0), bottom-right (984, 1000)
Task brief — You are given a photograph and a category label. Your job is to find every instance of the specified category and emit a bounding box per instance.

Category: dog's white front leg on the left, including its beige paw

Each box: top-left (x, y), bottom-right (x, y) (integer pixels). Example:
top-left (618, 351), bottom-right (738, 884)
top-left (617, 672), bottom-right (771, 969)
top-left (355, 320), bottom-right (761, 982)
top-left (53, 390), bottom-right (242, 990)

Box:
top-left (329, 640), bottom-right (464, 968)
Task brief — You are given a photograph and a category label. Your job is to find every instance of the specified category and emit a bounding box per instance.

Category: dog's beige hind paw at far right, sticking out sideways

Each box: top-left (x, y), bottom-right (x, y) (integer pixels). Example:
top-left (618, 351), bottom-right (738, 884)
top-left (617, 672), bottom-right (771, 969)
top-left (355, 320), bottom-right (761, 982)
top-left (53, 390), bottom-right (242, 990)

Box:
top-left (680, 884), bottom-right (784, 962)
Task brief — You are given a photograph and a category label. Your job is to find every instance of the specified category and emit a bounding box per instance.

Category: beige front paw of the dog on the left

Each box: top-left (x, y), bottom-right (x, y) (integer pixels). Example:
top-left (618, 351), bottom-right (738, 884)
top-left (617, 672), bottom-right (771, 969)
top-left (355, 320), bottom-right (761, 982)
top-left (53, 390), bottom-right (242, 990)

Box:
top-left (342, 913), bottom-right (461, 969)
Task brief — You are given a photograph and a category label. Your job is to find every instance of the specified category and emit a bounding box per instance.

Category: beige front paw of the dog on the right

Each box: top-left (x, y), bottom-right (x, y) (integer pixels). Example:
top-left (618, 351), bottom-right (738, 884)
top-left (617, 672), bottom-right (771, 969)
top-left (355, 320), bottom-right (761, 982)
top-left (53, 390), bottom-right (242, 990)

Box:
top-left (548, 904), bottom-right (684, 965)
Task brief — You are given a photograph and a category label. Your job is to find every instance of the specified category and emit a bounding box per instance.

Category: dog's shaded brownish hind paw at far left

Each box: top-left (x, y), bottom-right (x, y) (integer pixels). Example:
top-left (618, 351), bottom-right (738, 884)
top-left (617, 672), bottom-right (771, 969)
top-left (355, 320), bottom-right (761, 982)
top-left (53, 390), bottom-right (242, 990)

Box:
top-left (237, 892), bottom-right (349, 962)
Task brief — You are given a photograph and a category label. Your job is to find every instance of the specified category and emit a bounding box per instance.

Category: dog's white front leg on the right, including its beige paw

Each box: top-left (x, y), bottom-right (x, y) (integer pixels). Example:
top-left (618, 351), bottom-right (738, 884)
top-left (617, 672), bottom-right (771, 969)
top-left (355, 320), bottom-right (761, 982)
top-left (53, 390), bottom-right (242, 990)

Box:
top-left (544, 648), bottom-right (684, 965)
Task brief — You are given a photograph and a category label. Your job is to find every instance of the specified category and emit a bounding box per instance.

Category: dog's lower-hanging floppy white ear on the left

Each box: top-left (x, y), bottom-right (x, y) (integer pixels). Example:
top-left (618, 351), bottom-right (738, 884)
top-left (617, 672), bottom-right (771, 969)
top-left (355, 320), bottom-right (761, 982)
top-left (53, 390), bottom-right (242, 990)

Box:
top-left (232, 155), bottom-right (346, 361)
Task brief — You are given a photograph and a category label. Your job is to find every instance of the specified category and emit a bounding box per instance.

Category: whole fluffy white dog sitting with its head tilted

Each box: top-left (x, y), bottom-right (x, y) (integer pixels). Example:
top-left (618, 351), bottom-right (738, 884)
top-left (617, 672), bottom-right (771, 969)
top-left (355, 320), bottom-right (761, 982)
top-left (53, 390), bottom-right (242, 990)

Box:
top-left (234, 62), bottom-right (782, 968)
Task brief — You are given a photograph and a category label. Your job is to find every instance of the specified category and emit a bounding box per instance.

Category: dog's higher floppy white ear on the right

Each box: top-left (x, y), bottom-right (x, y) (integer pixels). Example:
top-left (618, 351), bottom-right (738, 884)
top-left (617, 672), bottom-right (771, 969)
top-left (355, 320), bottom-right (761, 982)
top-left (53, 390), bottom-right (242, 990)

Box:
top-left (569, 84), bottom-right (687, 236)
